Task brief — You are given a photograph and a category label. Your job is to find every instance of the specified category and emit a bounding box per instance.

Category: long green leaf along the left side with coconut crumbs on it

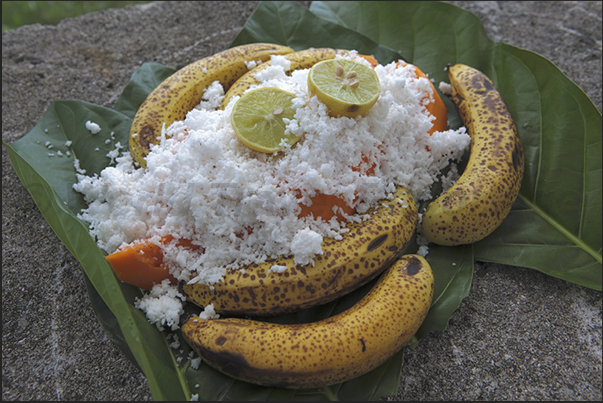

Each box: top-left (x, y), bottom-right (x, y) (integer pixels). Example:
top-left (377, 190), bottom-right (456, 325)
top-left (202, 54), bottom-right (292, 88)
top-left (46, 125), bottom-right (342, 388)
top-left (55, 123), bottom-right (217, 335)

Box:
top-left (3, 110), bottom-right (188, 400)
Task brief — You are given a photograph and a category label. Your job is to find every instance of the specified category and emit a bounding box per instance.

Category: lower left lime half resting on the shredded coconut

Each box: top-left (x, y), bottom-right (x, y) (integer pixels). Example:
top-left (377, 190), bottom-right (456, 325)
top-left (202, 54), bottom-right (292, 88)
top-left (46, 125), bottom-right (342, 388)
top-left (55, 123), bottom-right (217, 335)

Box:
top-left (230, 87), bottom-right (300, 153)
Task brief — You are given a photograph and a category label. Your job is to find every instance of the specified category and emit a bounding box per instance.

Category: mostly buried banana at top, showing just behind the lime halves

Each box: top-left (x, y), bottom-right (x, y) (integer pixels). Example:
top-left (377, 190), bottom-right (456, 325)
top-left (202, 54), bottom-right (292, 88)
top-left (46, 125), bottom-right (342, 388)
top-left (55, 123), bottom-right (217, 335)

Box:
top-left (220, 48), bottom-right (344, 109)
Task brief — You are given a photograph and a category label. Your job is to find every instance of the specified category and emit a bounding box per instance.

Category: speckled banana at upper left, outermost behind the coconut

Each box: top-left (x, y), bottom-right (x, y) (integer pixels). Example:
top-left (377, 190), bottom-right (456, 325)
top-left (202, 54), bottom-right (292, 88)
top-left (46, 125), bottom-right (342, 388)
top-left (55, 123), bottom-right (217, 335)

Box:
top-left (129, 43), bottom-right (293, 168)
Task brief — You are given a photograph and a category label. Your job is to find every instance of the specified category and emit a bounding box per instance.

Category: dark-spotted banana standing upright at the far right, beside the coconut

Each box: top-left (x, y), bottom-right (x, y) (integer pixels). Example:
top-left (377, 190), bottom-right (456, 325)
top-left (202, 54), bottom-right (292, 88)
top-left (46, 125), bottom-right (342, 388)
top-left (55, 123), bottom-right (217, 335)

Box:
top-left (422, 64), bottom-right (524, 245)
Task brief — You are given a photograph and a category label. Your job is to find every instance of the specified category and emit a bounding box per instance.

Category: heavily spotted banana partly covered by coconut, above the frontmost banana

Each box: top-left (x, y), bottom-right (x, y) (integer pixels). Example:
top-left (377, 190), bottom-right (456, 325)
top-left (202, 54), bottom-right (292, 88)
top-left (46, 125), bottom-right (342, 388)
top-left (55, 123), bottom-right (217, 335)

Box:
top-left (180, 187), bottom-right (418, 316)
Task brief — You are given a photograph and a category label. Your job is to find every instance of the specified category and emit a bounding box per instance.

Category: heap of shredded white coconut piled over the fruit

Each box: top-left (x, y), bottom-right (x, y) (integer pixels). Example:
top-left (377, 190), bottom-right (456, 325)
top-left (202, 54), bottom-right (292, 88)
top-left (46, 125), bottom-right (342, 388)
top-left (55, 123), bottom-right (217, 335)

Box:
top-left (74, 53), bottom-right (470, 326)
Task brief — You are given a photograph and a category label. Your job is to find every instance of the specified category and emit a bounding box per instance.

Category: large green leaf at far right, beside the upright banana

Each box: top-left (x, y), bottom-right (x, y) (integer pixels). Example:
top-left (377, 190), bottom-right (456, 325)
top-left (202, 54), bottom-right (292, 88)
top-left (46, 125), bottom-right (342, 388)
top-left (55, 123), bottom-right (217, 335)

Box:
top-left (475, 44), bottom-right (602, 290)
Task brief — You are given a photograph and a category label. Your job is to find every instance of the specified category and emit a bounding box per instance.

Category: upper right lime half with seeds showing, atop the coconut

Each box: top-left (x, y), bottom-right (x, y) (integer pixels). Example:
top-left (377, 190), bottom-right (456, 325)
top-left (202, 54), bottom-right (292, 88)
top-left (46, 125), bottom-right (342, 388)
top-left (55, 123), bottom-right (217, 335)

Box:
top-left (308, 59), bottom-right (381, 118)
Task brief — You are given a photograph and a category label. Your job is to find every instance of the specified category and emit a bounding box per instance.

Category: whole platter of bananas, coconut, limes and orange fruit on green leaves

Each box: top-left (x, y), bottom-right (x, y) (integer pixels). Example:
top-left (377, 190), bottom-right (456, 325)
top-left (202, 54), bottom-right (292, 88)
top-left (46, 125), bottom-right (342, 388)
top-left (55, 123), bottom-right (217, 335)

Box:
top-left (6, 2), bottom-right (601, 400)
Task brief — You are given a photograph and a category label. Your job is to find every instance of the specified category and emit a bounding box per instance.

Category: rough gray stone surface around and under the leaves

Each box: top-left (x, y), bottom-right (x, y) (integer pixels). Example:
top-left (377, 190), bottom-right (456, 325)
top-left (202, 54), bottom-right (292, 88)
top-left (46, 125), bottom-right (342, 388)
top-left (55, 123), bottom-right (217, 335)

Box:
top-left (2, 1), bottom-right (602, 401)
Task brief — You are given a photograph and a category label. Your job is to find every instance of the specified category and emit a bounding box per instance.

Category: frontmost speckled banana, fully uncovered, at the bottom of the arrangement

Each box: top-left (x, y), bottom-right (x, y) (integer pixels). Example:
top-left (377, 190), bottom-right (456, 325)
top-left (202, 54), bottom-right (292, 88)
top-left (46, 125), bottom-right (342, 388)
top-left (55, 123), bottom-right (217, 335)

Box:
top-left (182, 255), bottom-right (434, 389)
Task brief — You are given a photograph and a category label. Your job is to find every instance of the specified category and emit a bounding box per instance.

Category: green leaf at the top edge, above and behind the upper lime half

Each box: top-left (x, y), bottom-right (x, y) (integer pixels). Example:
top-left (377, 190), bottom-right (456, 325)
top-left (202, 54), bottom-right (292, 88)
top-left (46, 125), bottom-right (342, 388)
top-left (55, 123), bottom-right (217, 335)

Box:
top-left (310, 1), bottom-right (494, 76)
